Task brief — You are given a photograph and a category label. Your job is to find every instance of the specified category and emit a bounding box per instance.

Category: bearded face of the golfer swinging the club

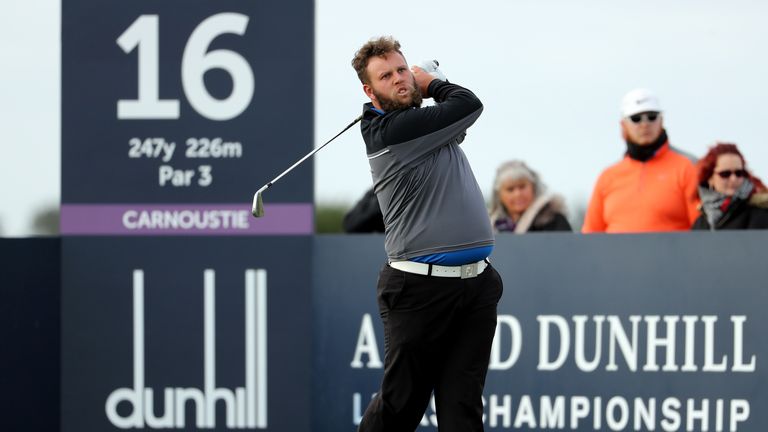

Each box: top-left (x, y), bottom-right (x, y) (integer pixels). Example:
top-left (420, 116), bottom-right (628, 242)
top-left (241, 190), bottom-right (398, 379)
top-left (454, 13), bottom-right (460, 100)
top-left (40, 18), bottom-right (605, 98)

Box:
top-left (367, 52), bottom-right (416, 106)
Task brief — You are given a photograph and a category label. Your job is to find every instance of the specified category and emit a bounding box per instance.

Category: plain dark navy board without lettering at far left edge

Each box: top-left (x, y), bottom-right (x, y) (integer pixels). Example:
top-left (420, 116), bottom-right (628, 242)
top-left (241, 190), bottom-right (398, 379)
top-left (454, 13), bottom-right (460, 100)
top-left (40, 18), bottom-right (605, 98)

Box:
top-left (0, 237), bottom-right (61, 431)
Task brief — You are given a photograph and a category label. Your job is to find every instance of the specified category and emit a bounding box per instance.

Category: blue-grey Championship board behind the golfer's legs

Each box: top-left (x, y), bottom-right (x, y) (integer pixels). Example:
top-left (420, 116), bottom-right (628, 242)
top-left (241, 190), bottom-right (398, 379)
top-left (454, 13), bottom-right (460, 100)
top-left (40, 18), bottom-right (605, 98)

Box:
top-left (313, 232), bottom-right (768, 432)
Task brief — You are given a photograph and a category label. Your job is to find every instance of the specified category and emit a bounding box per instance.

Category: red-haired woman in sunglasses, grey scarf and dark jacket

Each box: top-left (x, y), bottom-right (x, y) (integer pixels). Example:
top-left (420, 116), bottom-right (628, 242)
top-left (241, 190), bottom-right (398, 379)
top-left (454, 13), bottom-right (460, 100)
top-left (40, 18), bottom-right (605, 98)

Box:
top-left (692, 143), bottom-right (768, 231)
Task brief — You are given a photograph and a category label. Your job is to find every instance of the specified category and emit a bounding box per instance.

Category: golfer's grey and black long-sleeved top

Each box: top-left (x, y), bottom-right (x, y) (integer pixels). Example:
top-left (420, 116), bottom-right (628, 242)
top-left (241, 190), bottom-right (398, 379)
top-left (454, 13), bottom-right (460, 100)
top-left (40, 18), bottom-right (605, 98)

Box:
top-left (361, 80), bottom-right (493, 260)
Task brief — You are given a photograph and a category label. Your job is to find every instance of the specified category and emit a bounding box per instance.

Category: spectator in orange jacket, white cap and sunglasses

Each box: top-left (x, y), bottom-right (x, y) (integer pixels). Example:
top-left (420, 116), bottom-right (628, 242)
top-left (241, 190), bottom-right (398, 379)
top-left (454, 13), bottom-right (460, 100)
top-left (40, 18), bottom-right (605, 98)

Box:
top-left (582, 89), bottom-right (698, 233)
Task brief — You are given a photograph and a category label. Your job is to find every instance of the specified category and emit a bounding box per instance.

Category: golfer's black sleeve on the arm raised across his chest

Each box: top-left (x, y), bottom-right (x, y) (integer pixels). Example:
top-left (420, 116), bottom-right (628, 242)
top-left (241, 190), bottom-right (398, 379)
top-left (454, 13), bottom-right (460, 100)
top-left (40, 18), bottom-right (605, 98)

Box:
top-left (370, 80), bottom-right (483, 146)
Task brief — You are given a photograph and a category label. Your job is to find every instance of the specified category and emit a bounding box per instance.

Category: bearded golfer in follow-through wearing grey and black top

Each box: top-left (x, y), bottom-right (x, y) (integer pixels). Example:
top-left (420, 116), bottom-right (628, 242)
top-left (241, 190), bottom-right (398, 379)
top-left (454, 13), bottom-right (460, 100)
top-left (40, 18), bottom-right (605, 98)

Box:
top-left (352, 37), bottom-right (502, 432)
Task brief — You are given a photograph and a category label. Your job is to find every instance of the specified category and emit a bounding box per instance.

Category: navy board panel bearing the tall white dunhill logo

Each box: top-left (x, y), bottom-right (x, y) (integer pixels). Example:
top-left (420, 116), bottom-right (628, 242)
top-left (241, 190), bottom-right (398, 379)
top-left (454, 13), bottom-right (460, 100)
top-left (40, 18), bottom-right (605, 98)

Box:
top-left (62, 237), bottom-right (311, 432)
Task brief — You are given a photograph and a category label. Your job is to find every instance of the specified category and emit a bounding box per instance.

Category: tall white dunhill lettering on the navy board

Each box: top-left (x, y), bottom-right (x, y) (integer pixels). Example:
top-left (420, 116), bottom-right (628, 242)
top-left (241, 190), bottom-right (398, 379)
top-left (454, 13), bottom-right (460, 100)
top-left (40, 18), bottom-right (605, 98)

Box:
top-left (105, 269), bottom-right (267, 429)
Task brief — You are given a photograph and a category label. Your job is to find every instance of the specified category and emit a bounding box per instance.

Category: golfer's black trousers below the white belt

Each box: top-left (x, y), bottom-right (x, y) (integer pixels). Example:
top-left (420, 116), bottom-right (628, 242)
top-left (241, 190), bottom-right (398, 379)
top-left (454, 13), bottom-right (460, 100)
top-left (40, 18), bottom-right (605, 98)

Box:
top-left (358, 265), bottom-right (503, 432)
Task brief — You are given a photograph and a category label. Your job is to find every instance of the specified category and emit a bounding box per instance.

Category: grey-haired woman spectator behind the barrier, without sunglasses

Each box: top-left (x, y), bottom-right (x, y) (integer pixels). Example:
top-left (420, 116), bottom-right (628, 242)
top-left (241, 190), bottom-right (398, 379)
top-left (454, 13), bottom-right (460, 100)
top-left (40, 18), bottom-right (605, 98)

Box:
top-left (491, 160), bottom-right (571, 234)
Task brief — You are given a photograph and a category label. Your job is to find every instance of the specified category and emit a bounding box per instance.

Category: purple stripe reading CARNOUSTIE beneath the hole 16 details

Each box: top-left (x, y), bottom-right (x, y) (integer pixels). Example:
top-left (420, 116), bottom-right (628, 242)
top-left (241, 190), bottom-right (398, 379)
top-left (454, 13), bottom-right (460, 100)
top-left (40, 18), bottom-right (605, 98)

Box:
top-left (61, 203), bottom-right (314, 236)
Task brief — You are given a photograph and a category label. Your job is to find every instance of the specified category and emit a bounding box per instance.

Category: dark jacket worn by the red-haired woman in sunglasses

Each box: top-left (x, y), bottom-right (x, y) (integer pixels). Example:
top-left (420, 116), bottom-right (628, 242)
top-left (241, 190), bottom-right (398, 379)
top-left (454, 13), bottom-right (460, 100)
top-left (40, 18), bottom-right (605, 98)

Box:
top-left (691, 193), bottom-right (768, 230)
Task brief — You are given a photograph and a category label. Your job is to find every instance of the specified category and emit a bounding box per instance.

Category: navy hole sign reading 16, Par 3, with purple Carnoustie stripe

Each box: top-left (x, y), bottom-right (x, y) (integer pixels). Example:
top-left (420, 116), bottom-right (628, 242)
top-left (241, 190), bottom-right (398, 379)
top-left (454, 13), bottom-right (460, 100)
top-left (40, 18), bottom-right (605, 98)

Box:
top-left (61, 0), bottom-right (314, 236)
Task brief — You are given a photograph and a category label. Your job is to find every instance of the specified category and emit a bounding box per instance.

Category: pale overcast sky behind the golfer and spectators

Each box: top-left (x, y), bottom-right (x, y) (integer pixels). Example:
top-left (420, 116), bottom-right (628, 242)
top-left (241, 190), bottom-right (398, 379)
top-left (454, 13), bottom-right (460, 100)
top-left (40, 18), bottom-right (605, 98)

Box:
top-left (0, 0), bottom-right (768, 236)
